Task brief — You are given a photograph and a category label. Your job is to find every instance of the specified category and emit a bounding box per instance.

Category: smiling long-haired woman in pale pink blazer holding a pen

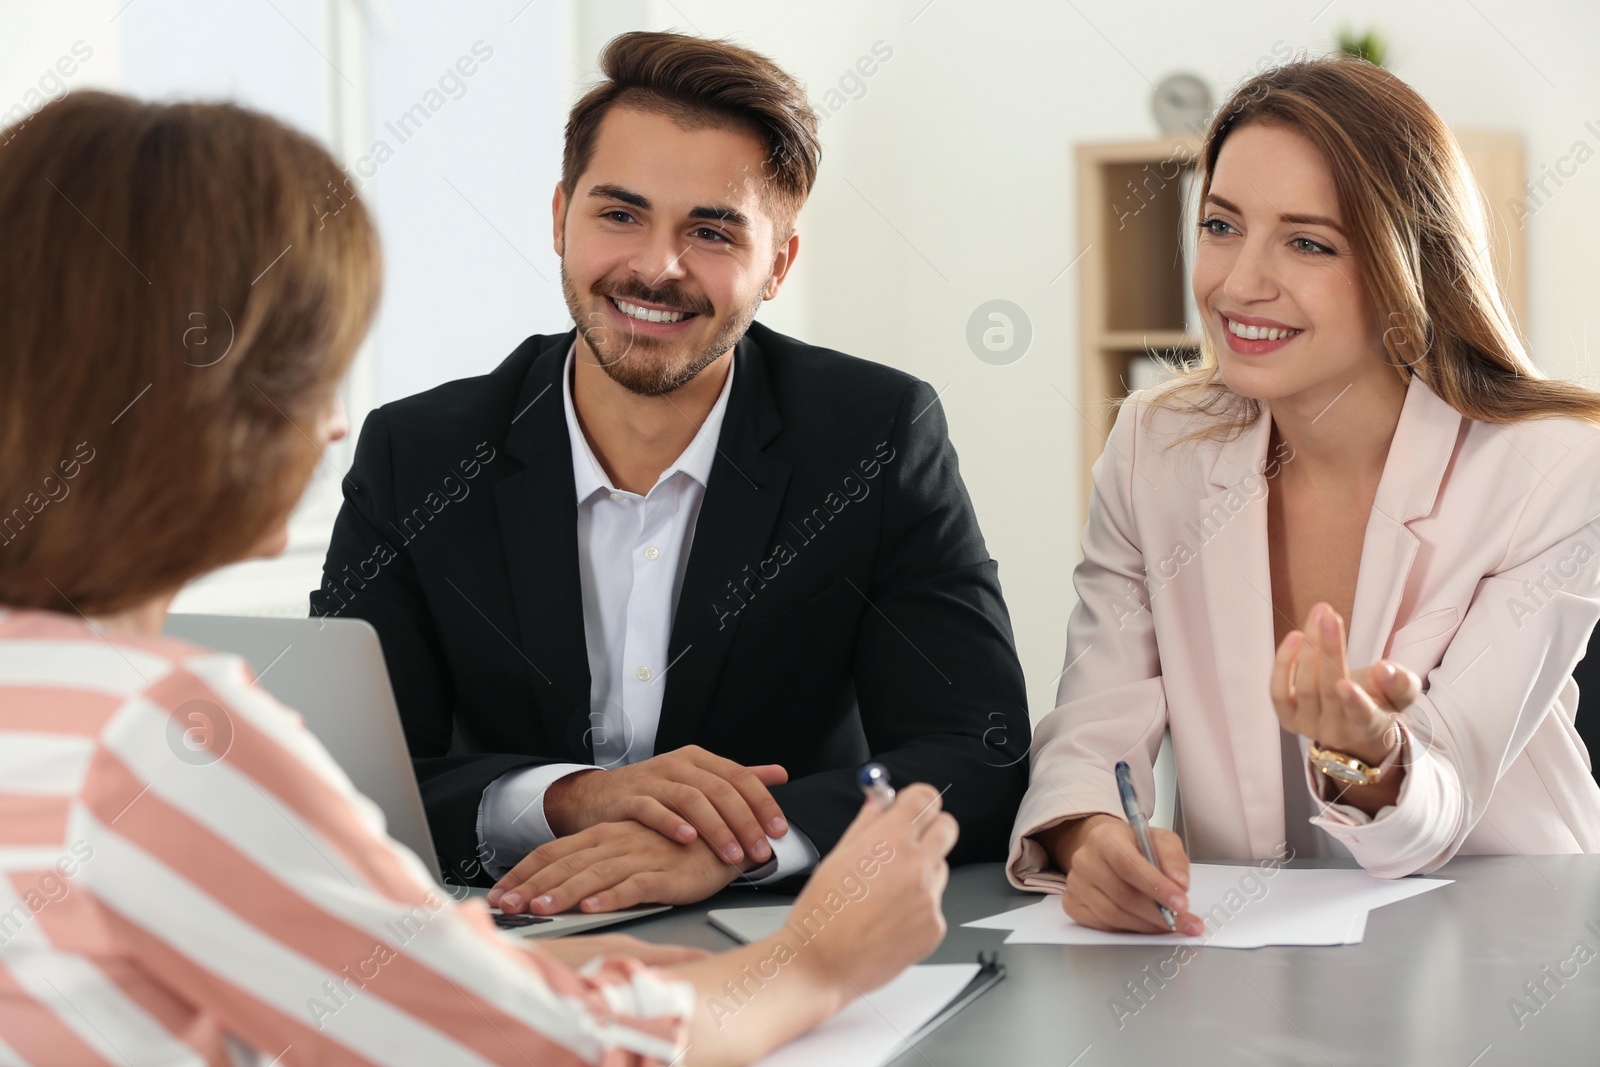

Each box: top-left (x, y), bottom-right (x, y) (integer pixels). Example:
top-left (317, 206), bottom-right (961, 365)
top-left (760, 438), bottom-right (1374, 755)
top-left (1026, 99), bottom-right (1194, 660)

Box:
top-left (1008, 59), bottom-right (1600, 933)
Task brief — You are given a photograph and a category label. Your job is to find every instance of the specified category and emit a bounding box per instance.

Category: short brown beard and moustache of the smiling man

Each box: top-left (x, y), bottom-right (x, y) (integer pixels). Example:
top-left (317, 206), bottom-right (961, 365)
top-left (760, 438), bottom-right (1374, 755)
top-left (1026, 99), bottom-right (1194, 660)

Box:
top-left (562, 262), bottom-right (771, 397)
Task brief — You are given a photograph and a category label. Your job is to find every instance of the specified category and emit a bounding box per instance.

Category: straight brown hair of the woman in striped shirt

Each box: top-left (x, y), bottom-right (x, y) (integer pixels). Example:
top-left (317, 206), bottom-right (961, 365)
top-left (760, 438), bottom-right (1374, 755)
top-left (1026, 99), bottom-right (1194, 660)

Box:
top-left (0, 93), bottom-right (381, 614)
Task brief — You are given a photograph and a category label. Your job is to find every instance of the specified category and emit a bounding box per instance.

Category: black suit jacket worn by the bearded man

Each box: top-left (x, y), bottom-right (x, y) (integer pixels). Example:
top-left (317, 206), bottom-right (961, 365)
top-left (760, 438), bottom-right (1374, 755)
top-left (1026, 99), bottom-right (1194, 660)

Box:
top-left (312, 325), bottom-right (1030, 883)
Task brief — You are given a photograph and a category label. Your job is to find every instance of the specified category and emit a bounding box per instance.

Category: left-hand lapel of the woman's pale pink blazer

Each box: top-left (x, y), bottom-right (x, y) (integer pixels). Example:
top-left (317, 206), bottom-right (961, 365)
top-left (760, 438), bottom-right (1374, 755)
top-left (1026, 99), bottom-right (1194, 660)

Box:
top-left (1184, 405), bottom-right (1283, 856)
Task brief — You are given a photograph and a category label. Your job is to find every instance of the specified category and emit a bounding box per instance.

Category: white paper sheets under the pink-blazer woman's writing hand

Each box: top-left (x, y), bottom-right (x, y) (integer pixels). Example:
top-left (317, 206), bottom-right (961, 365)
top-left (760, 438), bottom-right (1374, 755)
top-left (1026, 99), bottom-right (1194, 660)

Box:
top-left (963, 864), bottom-right (1450, 949)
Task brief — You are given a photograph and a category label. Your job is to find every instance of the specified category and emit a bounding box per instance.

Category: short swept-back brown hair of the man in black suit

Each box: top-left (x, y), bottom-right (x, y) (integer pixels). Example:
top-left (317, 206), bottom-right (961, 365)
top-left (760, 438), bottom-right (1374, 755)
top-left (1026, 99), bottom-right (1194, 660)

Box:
top-left (562, 30), bottom-right (822, 240)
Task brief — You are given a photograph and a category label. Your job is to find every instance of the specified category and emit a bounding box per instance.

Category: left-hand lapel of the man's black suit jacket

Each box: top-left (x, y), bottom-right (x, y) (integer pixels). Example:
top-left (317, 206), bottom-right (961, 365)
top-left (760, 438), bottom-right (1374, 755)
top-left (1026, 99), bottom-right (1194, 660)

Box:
top-left (494, 331), bottom-right (592, 763)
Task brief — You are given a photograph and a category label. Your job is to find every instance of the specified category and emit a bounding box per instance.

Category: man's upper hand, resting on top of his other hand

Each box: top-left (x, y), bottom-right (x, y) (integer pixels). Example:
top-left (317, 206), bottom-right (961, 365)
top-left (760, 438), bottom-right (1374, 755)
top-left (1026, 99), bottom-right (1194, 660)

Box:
top-left (547, 745), bottom-right (789, 870)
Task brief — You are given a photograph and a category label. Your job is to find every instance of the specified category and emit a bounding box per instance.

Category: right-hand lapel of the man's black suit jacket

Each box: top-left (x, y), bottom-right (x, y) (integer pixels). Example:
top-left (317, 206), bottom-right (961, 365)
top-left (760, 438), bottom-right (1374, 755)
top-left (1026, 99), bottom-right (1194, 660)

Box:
top-left (656, 334), bottom-right (794, 752)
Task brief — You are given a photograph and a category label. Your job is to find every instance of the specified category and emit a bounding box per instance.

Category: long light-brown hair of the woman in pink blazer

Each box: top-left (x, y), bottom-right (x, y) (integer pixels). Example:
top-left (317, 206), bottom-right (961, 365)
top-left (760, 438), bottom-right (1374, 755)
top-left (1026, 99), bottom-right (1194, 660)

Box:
top-left (1154, 56), bottom-right (1600, 438)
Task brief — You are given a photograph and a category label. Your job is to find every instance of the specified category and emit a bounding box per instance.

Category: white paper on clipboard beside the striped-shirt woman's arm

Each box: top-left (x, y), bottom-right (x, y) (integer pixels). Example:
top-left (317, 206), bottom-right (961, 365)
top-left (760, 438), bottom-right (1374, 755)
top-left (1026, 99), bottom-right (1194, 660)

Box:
top-left (757, 963), bottom-right (978, 1067)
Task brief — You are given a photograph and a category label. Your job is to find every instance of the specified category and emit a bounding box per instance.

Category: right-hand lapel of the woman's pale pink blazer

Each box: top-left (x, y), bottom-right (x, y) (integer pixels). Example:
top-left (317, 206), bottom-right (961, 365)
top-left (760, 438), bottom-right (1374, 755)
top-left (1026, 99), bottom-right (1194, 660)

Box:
top-left (1347, 374), bottom-right (1462, 667)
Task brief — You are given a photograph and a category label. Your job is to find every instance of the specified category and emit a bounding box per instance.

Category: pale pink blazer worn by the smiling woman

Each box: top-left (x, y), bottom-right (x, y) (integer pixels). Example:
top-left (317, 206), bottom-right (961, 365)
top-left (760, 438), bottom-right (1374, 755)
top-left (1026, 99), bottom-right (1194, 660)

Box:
top-left (1006, 378), bottom-right (1600, 889)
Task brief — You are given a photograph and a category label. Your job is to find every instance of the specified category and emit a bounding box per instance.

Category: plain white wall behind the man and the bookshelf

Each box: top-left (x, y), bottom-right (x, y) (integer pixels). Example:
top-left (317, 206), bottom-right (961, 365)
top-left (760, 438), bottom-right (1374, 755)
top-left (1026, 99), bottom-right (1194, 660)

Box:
top-left (574, 0), bottom-right (1600, 715)
